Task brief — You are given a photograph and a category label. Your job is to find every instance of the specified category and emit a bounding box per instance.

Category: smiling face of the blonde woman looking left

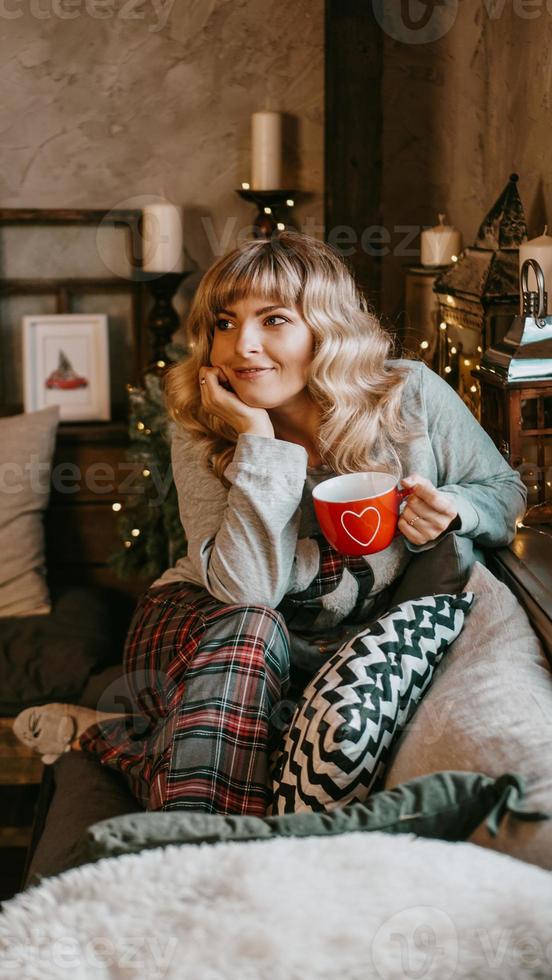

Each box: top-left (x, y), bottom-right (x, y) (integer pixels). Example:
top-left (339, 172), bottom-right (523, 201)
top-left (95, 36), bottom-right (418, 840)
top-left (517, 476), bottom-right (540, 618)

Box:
top-left (211, 296), bottom-right (314, 409)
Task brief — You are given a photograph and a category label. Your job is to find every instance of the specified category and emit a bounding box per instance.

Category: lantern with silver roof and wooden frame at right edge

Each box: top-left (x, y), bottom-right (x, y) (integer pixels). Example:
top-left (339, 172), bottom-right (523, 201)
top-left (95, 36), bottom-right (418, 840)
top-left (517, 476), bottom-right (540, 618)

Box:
top-left (474, 259), bottom-right (552, 504)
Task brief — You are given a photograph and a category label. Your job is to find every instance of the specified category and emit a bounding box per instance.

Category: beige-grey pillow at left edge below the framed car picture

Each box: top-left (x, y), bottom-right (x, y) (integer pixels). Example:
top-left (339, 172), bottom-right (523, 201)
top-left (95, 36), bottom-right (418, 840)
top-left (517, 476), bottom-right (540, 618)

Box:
top-left (0, 405), bottom-right (59, 617)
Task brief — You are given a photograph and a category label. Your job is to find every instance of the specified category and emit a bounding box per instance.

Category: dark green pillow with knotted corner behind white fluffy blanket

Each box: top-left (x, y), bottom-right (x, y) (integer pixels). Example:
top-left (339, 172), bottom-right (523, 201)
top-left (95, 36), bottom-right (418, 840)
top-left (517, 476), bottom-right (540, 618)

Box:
top-left (72, 772), bottom-right (547, 866)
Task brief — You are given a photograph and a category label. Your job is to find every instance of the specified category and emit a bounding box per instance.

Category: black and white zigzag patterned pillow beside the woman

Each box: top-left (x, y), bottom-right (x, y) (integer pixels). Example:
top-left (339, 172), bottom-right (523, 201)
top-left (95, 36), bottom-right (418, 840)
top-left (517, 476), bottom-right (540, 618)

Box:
top-left (271, 592), bottom-right (474, 814)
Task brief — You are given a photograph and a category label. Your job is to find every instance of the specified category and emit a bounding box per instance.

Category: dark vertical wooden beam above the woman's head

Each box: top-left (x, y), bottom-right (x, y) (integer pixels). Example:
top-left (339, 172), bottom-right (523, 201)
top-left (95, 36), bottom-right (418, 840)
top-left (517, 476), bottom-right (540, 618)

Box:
top-left (325, 0), bottom-right (383, 308)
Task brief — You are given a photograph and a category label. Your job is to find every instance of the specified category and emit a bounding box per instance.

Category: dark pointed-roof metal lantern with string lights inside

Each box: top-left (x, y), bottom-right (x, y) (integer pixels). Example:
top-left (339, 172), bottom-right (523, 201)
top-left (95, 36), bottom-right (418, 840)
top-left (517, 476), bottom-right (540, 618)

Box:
top-left (433, 174), bottom-right (527, 419)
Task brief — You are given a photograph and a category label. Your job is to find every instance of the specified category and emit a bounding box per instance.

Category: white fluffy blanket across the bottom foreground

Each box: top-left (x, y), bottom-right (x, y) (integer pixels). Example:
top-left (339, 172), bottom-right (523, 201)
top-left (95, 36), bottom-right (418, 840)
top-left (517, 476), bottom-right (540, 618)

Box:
top-left (0, 833), bottom-right (552, 980)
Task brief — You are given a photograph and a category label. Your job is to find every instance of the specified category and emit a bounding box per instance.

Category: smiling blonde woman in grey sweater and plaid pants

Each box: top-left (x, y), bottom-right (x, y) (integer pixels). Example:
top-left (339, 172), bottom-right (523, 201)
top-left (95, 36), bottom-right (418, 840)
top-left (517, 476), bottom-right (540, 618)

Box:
top-left (17, 232), bottom-right (526, 815)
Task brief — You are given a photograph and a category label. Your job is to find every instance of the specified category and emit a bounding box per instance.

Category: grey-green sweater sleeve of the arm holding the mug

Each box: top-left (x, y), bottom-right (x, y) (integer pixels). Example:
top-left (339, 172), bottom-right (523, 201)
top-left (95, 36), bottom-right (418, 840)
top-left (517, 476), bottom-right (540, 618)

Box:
top-left (406, 365), bottom-right (527, 551)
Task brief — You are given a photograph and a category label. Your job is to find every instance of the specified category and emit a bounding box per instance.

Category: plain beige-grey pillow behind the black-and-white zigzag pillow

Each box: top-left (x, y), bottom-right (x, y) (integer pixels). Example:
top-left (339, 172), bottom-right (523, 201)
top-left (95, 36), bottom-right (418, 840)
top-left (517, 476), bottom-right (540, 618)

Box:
top-left (385, 562), bottom-right (552, 869)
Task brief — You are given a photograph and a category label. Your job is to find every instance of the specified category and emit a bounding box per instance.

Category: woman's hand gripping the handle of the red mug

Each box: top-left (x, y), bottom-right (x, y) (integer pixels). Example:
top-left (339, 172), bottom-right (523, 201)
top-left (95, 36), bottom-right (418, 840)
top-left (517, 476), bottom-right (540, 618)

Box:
top-left (398, 473), bottom-right (458, 545)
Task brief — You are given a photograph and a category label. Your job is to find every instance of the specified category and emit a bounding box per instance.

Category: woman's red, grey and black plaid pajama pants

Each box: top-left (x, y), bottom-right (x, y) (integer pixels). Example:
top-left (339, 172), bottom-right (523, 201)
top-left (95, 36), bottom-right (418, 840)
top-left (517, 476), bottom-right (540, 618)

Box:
top-left (79, 543), bottom-right (376, 816)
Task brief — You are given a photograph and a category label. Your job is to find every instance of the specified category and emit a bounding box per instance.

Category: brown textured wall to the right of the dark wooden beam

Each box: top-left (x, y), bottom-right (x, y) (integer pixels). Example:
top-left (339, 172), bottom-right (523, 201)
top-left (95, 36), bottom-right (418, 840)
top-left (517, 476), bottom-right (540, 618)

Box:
top-left (382, 0), bottom-right (552, 320)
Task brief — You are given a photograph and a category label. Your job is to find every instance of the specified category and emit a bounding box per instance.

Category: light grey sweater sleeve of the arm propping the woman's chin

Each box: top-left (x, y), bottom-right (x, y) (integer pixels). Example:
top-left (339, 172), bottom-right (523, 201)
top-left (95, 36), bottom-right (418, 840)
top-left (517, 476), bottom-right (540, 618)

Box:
top-left (171, 429), bottom-right (310, 608)
